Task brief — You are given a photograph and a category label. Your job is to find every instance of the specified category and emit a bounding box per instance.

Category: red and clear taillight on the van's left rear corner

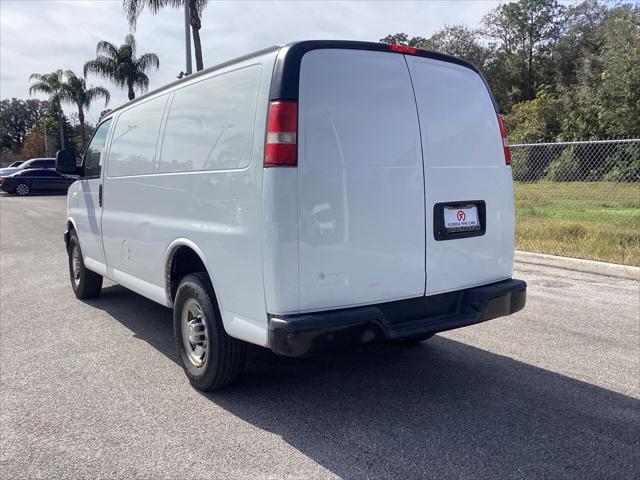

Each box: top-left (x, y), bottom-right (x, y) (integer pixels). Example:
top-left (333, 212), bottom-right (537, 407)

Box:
top-left (264, 100), bottom-right (298, 167)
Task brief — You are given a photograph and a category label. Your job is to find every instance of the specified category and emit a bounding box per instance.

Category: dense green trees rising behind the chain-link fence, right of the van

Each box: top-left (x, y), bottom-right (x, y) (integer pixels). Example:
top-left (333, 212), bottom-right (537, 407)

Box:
top-left (381, 0), bottom-right (640, 143)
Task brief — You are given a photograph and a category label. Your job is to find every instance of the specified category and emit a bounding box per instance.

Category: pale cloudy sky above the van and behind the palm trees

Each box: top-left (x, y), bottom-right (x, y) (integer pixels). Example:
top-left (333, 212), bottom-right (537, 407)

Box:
top-left (0, 0), bottom-right (501, 121)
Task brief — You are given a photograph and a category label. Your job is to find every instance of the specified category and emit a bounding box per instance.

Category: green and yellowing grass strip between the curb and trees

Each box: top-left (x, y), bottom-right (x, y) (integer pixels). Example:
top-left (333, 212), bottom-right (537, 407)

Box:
top-left (514, 182), bottom-right (640, 266)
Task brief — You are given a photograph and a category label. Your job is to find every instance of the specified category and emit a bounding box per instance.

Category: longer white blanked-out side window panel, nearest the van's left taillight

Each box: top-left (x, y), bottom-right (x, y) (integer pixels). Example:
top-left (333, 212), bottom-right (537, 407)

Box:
top-left (159, 65), bottom-right (262, 172)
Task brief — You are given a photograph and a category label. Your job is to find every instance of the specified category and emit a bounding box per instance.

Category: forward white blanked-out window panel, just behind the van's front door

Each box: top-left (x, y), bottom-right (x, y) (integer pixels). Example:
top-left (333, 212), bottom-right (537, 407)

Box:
top-left (108, 95), bottom-right (167, 177)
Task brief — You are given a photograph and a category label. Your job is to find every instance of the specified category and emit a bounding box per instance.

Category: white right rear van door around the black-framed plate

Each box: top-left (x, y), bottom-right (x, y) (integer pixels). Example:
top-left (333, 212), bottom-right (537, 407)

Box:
top-left (405, 55), bottom-right (514, 295)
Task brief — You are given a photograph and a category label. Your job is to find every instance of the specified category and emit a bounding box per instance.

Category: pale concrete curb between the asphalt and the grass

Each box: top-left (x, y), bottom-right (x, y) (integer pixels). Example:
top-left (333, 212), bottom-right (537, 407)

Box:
top-left (514, 250), bottom-right (640, 280)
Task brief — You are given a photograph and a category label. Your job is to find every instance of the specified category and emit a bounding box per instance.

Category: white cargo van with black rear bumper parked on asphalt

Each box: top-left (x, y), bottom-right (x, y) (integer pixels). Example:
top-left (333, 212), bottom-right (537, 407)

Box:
top-left (57, 41), bottom-right (526, 390)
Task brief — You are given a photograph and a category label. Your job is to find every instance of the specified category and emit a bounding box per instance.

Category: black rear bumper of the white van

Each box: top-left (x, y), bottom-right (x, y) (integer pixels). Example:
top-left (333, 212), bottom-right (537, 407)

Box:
top-left (269, 279), bottom-right (527, 357)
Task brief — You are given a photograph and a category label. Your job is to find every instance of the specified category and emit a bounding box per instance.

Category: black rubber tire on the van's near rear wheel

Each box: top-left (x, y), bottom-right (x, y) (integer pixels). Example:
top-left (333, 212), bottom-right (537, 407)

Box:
top-left (173, 273), bottom-right (247, 391)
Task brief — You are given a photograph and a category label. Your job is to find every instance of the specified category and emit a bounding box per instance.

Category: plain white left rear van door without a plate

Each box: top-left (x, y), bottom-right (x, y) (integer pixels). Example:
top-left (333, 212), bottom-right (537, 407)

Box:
top-left (297, 49), bottom-right (425, 311)
